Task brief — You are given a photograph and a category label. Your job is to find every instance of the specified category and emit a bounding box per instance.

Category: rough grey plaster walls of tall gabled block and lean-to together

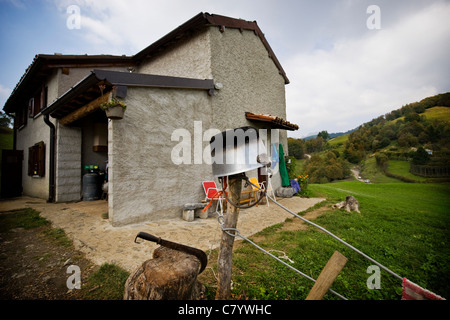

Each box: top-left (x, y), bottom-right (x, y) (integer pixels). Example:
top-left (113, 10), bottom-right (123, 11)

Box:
top-left (108, 27), bottom-right (287, 226)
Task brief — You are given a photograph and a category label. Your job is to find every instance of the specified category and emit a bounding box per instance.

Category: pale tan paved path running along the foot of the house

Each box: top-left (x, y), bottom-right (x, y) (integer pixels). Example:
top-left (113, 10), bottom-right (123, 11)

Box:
top-left (0, 197), bottom-right (324, 271)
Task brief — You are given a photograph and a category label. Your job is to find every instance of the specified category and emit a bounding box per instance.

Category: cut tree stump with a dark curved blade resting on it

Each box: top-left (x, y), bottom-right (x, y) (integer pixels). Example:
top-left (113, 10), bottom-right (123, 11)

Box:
top-left (124, 246), bottom-right (205, 300)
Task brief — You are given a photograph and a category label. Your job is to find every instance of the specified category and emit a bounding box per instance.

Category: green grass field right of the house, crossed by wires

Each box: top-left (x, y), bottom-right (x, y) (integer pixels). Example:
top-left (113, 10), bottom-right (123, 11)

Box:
top-left (203, 181), bottom-right (450, 300)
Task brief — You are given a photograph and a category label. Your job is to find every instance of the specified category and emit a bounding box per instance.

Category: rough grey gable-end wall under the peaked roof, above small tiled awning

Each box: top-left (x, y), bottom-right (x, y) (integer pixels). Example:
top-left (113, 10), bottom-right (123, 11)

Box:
top-left (209, 27), bottom-right (288, 189)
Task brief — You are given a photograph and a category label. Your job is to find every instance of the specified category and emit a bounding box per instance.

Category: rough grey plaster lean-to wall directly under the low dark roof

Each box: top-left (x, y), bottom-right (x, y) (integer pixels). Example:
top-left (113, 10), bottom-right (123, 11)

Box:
top-left (108, 87), bottom-right (212, 226)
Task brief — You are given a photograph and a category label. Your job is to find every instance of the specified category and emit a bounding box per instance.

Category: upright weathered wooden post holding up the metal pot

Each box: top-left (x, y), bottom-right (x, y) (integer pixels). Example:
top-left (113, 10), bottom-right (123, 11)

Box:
top-left (216, 175), bottom-right (242, 300)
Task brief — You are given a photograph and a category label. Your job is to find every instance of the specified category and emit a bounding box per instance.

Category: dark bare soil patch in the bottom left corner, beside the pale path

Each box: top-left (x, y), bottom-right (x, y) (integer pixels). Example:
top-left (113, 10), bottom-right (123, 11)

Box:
top-left (0, 222), bottom-right (96, 300)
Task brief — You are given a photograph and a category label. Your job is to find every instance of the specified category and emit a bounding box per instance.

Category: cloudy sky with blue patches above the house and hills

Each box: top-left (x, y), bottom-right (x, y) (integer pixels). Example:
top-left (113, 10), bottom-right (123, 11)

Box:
top-left (0, 0), bottom-right (450, 137)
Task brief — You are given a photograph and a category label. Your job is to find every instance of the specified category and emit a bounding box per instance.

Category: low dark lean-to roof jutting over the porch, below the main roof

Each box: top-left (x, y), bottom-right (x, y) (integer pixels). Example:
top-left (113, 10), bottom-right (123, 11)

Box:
top-left (41, 69), bottom-right (214, 119)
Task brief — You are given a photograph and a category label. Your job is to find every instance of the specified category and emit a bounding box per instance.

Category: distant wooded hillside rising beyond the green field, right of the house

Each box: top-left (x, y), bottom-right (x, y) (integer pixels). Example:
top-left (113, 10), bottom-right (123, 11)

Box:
top-left (288, 92), bottom-right (450, 183)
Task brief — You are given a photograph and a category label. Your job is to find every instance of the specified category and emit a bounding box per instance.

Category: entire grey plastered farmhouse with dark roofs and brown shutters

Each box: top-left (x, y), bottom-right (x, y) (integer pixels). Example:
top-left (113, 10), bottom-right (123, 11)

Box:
top-left (3, 13), bottom-right (298, 226)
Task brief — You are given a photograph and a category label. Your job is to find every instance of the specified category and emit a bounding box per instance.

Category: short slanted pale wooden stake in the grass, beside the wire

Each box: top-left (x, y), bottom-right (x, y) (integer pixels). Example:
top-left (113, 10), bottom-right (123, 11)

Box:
top-left (306, 251), bottom-right (347, 300)
